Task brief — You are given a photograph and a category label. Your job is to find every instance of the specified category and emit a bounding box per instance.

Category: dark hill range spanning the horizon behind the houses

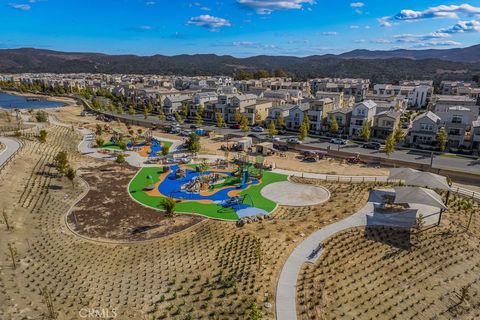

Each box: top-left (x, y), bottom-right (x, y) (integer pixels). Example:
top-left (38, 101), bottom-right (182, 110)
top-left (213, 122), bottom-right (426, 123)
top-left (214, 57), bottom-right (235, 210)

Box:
top-left (0, 45), bottom-right (480, 82)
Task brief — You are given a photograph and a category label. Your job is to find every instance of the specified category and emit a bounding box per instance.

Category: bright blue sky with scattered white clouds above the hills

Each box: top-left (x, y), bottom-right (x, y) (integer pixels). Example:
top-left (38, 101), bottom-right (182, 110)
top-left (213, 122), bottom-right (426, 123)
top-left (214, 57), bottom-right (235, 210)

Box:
top-left (0, 0), bottom-right (480, 57)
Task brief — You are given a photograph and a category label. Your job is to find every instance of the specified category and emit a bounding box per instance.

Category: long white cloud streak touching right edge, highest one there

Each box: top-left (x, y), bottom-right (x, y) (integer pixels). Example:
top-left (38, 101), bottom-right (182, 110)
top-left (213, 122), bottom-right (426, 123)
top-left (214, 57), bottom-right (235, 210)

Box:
top-left (378, 3), bottom-right (480, 27)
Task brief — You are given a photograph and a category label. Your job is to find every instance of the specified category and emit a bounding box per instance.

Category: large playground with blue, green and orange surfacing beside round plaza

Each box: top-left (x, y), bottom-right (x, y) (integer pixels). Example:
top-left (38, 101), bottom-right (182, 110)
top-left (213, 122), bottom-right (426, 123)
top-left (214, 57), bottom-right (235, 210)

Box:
top-left (128, 158), bottom-right (287, 221)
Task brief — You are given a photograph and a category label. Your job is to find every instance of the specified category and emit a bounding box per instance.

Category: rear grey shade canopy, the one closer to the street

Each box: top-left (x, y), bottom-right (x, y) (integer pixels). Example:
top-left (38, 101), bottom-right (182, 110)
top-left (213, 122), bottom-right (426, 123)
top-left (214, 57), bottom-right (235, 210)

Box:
top-left (388, 168), bottom-right (450, 190)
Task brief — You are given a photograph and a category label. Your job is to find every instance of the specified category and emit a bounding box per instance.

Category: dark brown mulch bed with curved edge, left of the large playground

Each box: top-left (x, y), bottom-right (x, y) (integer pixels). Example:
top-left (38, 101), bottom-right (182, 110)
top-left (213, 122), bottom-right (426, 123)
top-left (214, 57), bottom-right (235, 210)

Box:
top-left (67, 163), bottom-right (204, 241)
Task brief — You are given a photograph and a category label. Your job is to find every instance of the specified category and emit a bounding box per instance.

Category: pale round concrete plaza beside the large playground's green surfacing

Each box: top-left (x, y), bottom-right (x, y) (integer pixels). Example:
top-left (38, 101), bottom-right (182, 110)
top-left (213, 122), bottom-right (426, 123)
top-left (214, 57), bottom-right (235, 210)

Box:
top-left (261, 181), bottom-right (330, 206)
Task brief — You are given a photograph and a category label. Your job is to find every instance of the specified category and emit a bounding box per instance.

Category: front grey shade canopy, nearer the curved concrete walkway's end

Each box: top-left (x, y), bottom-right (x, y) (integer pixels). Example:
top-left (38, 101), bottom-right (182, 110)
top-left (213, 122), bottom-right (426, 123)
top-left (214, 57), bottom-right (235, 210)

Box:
top-left (394, 187), bottom-right (447, 209)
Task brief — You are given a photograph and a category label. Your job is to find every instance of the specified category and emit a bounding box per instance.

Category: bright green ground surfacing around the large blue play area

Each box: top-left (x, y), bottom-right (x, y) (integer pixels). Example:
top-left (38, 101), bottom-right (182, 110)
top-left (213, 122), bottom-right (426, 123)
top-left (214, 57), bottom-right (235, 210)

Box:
top-left (128, 167), bottom-right (288, 221)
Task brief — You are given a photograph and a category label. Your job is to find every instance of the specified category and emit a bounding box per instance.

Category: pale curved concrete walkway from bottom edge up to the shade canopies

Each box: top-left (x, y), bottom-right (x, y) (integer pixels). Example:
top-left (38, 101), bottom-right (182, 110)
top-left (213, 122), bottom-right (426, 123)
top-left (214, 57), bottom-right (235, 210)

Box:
top-left (276, 189), bottom-right (439, 320)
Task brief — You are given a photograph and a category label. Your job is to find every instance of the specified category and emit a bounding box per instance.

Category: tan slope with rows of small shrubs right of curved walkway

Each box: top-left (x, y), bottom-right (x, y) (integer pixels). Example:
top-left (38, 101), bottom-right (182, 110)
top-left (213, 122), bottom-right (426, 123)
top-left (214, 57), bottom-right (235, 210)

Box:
top-left (297, 197), bottom-right (480, 319)
